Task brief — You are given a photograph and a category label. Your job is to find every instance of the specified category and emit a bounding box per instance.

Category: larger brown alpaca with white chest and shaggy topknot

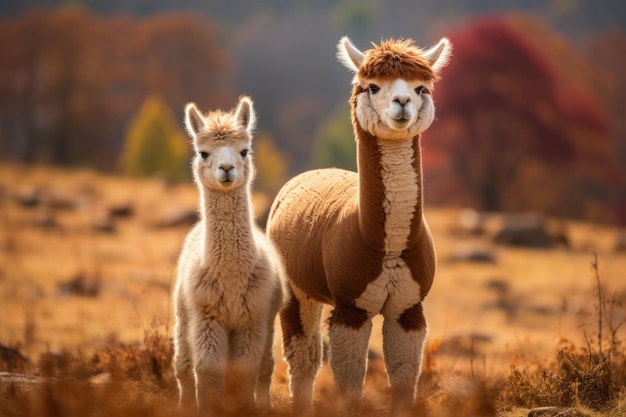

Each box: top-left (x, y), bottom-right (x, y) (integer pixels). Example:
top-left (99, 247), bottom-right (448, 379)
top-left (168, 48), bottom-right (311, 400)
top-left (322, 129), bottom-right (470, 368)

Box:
top-left (268, 37), bottom-right (451, 415)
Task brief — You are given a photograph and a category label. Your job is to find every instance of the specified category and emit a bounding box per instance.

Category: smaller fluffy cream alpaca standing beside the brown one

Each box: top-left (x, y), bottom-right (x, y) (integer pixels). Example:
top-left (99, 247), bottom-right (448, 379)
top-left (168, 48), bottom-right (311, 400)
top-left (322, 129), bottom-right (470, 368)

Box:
top-left (174, 97), bottom-right (283, 415)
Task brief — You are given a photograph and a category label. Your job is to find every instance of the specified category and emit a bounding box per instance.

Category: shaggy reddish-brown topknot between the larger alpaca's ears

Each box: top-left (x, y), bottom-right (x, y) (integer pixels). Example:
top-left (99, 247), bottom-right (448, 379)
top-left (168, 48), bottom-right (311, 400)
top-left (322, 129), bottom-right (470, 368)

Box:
top-left (358, 39), bottom-right (437, 81)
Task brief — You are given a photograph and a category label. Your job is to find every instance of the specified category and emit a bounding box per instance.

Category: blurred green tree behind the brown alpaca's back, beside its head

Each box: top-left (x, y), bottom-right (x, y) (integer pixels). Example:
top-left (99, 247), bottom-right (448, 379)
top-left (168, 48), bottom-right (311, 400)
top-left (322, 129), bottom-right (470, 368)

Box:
top-left (311, 103), bottom-right (356, 171)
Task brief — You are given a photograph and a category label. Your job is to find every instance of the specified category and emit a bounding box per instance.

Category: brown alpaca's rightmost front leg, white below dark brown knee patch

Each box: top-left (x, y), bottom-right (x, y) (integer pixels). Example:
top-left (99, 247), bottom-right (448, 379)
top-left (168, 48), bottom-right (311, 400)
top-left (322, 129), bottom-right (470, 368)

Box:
top-left (383, 303), bottom-right (428, 417)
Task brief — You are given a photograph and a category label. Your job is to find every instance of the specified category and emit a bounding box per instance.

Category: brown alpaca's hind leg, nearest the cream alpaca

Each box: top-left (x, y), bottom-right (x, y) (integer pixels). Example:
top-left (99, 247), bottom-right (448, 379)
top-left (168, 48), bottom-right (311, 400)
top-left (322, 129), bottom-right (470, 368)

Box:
top-left (280, 286), bottom-right (322, 415)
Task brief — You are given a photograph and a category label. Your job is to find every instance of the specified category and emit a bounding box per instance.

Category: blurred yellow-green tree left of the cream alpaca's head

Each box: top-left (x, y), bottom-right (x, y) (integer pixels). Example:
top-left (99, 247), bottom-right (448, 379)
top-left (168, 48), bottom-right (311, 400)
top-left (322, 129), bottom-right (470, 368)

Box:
top-left (121, 95), bottom-right (189, 180)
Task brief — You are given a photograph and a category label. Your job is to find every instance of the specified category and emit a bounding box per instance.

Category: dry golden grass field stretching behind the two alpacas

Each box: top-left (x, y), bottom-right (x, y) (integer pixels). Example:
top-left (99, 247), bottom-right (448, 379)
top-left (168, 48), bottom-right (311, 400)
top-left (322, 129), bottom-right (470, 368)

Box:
top-left (0, 165), bottom-right (626, 416)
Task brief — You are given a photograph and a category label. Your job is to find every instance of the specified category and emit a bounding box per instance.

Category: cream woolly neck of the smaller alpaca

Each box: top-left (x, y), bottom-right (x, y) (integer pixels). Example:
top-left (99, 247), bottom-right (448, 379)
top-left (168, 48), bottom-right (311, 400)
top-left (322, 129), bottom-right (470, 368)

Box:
top-left (199, 186), bottom-right (255, 266)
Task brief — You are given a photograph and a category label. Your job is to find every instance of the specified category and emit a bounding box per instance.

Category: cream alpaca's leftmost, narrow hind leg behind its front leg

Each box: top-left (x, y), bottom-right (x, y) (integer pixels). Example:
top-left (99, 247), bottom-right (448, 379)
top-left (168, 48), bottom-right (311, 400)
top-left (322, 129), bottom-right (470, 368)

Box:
top-left (174, 302), bottom-right (196, 411)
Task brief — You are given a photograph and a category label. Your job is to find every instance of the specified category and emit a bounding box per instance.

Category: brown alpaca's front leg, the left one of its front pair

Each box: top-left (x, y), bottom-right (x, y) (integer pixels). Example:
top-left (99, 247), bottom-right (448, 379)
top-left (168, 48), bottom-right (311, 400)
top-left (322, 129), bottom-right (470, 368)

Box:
top-left (328, 307), bottom-right (372, 414)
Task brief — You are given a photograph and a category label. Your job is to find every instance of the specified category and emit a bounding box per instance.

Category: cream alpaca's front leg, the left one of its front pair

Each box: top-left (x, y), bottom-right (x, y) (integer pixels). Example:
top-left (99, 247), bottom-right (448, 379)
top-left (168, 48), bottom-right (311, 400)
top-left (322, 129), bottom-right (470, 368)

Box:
top-left (193, 318), bottom-right (228, 416)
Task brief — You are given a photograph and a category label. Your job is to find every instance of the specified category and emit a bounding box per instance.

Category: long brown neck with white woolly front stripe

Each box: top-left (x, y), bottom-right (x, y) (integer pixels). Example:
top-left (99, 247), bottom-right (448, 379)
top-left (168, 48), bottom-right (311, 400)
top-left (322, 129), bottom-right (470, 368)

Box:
top-left (356, 128), bottom-right (423, 257)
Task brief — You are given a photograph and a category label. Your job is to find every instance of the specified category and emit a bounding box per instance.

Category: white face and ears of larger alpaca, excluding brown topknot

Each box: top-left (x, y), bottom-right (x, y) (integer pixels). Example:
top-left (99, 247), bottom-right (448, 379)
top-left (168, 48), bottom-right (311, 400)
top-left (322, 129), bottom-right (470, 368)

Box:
top-left (337, 37), bottom-right (451, 139)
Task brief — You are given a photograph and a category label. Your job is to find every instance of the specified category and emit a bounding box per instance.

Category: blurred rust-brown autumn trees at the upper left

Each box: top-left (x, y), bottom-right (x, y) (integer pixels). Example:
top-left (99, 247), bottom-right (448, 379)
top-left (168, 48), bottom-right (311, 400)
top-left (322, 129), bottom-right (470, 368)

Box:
top-left (0, 6), bottom-right (233, 170)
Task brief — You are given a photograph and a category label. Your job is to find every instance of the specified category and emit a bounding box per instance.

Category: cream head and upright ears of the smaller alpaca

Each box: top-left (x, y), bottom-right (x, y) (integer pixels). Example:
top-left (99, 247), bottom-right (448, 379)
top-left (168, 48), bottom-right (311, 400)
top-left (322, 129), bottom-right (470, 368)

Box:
top-left (185, 97), bottom-right (256, 191)
